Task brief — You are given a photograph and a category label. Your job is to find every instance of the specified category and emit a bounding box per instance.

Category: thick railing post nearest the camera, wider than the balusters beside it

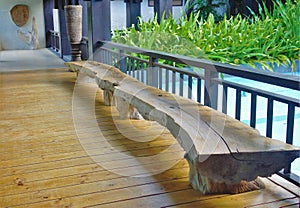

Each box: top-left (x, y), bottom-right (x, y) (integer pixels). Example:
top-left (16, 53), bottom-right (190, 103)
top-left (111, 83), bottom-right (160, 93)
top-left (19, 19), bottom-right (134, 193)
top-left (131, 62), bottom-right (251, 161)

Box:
top-left (204, 68), bottom-right (219, 109)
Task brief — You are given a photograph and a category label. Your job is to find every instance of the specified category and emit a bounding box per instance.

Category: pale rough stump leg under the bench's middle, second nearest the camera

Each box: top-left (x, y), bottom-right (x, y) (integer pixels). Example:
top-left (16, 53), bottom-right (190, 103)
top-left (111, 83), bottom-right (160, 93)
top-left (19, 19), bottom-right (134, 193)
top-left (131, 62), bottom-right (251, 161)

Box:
top-left (116, 97), bottom-right (142, 120)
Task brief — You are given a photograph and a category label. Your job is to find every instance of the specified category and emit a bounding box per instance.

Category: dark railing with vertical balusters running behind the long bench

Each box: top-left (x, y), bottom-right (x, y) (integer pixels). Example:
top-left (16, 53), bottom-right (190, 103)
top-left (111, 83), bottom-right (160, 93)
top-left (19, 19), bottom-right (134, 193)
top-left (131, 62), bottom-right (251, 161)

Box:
top-left (93, 41), bottom-right (300, 185)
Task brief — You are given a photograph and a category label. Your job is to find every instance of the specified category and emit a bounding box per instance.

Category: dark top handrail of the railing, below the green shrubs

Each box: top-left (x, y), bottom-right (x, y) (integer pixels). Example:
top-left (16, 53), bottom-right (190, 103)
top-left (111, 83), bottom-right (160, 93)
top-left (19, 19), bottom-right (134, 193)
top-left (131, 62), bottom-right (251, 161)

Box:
top-left (98, 41), bottom-right (300, 90)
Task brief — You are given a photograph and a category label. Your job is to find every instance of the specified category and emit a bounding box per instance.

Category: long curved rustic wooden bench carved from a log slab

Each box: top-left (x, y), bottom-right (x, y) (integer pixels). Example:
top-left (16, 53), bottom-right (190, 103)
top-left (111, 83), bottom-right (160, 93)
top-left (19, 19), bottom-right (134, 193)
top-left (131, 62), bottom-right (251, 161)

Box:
top-left (66, 61), bottom-right (300, 194)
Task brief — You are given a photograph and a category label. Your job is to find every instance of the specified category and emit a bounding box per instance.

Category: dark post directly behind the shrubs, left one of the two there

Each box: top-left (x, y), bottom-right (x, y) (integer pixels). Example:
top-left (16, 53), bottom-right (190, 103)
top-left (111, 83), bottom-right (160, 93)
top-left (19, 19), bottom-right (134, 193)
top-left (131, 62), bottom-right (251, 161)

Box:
top-left (124, 0), bottom-right (142, 29)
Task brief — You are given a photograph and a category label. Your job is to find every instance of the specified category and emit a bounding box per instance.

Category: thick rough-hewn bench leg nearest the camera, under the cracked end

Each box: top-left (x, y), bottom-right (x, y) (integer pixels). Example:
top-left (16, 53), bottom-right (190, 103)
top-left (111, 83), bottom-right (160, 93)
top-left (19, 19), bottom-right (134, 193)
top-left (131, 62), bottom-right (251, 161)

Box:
top-left (185, 154), bottom-right (264, 194)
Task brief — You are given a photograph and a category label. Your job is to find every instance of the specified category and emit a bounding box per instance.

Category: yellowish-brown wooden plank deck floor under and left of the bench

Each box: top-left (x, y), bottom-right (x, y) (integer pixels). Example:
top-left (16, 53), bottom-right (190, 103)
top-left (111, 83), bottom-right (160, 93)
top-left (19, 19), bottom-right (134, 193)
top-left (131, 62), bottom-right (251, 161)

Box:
top-left (0, 69), bottom-right (299, 208)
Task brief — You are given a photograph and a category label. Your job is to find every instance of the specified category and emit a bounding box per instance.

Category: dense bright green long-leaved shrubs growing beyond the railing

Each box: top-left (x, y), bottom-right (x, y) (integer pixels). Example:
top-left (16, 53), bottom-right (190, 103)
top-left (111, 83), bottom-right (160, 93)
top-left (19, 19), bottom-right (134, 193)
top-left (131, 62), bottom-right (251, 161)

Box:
top-left (112, 0), bottom-right (300, 70)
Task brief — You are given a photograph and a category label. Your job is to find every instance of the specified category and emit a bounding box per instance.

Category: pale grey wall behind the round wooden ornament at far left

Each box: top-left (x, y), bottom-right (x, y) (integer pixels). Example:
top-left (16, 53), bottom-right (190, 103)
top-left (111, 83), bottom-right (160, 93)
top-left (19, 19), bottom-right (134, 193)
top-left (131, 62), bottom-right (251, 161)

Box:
top-left (0, 0), bottom-right (45, 50)
